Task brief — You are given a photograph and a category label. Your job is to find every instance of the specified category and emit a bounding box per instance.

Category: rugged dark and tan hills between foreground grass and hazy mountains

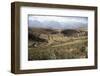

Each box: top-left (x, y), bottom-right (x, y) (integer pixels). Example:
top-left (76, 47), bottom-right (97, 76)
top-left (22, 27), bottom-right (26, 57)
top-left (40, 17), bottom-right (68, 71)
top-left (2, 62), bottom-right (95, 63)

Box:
top-left (28, 29), bottom-right (88, 46)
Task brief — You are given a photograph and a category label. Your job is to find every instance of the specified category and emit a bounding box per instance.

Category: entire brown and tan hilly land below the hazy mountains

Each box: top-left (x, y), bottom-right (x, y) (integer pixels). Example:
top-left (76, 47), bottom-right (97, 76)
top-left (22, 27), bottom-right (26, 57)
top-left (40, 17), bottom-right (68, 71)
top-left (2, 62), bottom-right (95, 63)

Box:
top-left (28, 28), bottom-right (88, 60)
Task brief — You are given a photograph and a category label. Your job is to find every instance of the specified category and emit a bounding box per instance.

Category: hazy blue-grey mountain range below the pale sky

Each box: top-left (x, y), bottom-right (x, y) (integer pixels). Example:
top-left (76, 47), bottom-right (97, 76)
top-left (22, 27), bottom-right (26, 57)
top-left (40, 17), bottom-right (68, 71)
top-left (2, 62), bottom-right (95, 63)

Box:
top-left (28, 20), bottom-right (88, 29)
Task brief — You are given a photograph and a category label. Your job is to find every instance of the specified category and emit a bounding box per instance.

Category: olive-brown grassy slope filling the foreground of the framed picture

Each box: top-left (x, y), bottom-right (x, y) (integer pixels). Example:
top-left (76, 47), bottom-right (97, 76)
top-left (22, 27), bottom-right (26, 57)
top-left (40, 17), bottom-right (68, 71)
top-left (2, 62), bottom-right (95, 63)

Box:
top-left (28, 37), bottom-right (87, 60)
